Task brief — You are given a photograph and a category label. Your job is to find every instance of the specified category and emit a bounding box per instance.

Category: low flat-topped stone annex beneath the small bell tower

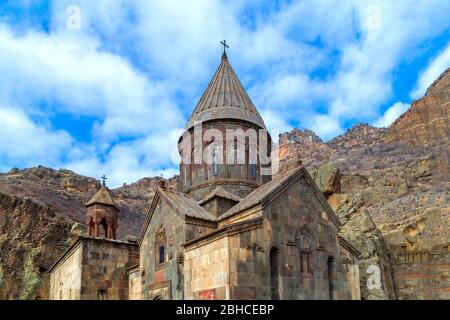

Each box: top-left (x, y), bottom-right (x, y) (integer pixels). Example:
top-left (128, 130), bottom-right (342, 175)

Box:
top-left (50, 236), bottom-right (139, 300)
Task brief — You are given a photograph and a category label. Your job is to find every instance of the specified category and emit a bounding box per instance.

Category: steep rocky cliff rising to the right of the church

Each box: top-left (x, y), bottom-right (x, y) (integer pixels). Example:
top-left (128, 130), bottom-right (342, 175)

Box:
top-left (280, 69), bottom-right (450, 299)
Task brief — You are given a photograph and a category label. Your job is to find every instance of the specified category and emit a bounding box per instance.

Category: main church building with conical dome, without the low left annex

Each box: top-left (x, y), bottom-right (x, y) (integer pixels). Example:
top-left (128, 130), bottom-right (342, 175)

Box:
top-left (135, 55), bottom-right (360, 300)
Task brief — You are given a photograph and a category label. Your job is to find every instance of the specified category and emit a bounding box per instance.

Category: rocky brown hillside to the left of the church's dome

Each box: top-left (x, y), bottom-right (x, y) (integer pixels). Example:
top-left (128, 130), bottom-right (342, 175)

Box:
top-left (0, 167), bottom-right (178, 299)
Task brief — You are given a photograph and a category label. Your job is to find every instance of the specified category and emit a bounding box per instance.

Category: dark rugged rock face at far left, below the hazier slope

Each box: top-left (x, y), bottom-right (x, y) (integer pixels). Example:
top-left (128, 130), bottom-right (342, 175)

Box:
top-left (0, 193), bottom-right (77, 299)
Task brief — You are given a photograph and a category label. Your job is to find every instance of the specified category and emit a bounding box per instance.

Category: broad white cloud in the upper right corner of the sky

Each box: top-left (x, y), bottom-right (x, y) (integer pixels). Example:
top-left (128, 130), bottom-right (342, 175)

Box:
top-left (329, 1), bottom-right (450, 120)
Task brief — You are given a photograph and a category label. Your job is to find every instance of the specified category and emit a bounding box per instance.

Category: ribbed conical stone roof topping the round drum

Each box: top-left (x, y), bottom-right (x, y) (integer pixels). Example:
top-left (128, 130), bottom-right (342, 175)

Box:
top-left (186, 53), bottom-right (266, 129)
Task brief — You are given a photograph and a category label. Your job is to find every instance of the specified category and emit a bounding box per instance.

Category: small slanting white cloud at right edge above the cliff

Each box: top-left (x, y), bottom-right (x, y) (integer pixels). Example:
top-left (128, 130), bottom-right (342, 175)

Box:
top-left (411, 44), bottom-right (450, 99)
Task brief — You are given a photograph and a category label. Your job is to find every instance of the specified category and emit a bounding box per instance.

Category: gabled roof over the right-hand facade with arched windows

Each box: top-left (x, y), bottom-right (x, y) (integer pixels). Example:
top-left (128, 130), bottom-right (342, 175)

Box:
top-left (217, 166), bottom-right (340, 226)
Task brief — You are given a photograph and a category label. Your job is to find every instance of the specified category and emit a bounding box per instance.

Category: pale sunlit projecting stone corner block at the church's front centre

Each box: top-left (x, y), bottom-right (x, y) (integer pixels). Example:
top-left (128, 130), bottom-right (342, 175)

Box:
top-left (184, 219), bottom-right (270, 300)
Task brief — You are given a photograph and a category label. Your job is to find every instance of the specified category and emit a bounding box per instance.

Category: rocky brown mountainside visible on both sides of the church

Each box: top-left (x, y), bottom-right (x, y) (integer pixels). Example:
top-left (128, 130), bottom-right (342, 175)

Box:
top-left (0, 70), bottom-right (450, 299)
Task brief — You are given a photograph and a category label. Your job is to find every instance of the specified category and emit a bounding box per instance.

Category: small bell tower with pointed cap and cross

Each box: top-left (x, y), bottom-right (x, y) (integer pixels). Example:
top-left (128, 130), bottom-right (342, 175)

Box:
top-left (86, 176), bottom-right (120, 240)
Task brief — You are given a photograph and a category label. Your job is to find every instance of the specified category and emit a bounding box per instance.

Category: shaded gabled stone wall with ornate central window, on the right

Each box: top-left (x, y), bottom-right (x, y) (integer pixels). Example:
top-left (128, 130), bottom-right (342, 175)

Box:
top-left (264, 177), bottom-right (352, 300)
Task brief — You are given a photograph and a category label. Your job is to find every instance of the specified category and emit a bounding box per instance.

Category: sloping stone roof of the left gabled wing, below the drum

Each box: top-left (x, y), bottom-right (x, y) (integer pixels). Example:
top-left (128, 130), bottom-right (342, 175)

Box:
top-left (158, 188), bottom-right (216, 221)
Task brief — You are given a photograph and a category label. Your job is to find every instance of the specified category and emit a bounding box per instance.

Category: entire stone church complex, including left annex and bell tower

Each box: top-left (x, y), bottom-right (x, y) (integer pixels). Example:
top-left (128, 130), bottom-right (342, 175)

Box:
top-left (49, 51), bottom-right (360, 300)
